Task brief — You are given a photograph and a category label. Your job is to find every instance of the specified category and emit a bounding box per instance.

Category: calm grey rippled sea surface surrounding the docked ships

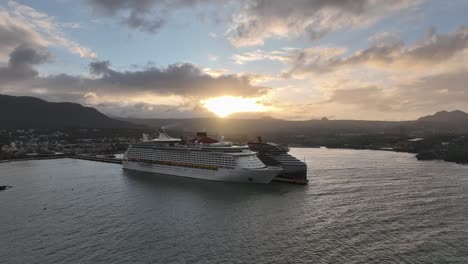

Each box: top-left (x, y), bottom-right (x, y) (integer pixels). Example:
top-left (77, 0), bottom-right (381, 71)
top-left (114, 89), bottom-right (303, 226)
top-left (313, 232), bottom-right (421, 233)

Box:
top-left (0, 149), bottom-right (468, 263)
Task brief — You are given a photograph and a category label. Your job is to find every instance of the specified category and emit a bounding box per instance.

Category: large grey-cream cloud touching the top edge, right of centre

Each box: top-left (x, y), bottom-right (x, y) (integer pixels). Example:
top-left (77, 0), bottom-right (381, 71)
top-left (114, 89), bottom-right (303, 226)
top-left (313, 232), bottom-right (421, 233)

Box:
top-left (227, 0), bottom-right (419, 47)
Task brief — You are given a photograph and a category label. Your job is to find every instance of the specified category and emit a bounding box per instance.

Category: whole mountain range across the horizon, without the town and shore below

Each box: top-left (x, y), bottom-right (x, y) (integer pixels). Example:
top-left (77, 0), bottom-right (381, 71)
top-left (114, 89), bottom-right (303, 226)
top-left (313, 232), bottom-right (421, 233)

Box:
top-left (0, 95), bottom-right (468, 137)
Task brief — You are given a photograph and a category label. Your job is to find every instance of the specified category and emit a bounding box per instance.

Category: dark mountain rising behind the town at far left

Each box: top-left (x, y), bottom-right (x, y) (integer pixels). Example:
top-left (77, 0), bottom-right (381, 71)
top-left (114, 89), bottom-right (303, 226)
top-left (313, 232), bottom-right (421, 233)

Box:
top-left (0, 94), bottom-right (135, 128)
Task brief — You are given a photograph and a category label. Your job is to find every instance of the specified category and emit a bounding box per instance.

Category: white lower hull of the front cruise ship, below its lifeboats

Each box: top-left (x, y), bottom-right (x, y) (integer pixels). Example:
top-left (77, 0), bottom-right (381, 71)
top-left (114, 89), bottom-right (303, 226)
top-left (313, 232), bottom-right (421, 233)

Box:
top-left (122, 160), bottom-right (282, 183)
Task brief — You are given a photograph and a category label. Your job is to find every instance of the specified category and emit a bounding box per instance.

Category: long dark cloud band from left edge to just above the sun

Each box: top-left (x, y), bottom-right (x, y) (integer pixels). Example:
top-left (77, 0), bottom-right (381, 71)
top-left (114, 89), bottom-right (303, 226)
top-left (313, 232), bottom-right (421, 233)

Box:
top-left (0, 59), bottom-right (268, 101)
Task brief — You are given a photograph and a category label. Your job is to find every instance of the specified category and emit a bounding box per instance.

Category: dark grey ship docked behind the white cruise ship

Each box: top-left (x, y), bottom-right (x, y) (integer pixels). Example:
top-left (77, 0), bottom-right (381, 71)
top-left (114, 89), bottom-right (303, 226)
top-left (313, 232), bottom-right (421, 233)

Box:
top-left (248, 137), bottom-right (308, 184)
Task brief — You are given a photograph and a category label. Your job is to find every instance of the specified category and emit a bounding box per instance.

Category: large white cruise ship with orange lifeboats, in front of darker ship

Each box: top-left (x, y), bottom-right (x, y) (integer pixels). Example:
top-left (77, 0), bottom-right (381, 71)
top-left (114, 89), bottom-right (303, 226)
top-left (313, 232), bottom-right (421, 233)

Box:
top-left (122, 129), bottom-right (283, 183)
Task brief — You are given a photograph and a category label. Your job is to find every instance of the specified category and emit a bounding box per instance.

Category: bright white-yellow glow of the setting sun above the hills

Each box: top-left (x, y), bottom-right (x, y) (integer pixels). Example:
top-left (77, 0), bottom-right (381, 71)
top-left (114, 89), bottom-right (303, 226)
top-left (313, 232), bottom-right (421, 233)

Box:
top-left (201, 96), bottom-right (267, 117)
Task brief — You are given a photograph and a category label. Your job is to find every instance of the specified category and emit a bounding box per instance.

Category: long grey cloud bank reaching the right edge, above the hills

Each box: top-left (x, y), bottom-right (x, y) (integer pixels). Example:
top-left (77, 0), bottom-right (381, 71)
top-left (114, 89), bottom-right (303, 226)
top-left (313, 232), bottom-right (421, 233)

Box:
top-left (286, 26), bottom-right (468, 76)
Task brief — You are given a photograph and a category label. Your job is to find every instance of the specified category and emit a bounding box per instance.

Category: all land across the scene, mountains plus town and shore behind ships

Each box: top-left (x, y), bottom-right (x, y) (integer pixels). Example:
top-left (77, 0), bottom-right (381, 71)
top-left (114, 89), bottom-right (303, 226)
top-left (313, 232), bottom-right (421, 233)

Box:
top-left (0, 95), bottom-right (468, 163)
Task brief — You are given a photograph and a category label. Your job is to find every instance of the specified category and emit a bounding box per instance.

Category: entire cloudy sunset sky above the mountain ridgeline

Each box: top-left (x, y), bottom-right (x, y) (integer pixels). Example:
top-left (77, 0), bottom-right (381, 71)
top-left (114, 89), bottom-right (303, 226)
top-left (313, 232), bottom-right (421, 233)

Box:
top-left (0, 0), bottom-right (468, 120)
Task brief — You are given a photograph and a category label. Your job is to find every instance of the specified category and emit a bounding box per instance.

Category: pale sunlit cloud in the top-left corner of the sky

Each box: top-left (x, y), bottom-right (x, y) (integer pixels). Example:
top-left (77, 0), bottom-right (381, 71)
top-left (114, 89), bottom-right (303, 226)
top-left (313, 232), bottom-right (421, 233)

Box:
top-left (0, 1), bottom-right (96, 59)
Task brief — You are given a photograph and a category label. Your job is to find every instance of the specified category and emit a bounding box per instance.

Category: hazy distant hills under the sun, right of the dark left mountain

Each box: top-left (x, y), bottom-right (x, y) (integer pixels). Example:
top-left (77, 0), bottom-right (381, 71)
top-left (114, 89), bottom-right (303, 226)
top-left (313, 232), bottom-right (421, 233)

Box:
top-left (120, 110), bottom-right (468, 136)
